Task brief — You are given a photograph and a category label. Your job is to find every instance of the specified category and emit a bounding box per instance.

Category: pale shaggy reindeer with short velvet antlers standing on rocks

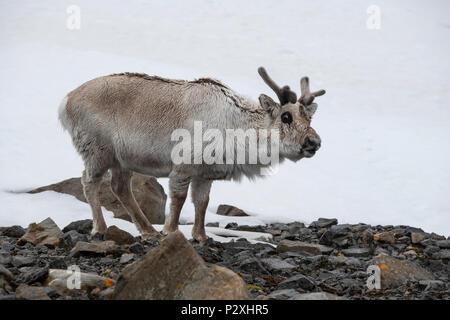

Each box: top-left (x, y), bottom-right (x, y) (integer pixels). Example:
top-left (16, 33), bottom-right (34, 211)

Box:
top-left (59, 67), bottom-right (325, 242)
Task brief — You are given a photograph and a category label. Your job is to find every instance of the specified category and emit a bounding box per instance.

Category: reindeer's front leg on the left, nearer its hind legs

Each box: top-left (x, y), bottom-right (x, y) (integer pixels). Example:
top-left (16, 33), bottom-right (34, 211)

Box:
top-left (164, 174), bottom-right (190, 233)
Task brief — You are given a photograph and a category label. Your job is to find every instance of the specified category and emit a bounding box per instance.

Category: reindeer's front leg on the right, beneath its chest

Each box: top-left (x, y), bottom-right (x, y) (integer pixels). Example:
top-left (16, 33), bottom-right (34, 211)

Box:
top-left (191, 177), bottom-right (212, 243)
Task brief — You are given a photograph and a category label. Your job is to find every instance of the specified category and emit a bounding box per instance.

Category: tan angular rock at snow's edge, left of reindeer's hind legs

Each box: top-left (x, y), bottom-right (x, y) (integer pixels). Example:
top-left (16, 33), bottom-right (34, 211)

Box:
top-left (18, 218), bottom-right (62, 248)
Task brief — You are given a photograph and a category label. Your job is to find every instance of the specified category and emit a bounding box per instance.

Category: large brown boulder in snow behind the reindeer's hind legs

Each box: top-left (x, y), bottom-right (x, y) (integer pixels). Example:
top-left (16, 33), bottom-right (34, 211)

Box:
top-left (29, 173), bottom-right (167, 224)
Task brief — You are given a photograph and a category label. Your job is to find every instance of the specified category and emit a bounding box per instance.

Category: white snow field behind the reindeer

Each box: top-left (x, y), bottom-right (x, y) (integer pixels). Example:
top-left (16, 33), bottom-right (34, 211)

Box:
top-left (0, 0), bottom-right (450, 236)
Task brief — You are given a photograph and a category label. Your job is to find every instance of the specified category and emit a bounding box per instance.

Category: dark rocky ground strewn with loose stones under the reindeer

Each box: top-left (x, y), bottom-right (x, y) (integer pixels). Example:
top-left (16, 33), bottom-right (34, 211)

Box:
top-left (0, 219), bottom-right (450, 300)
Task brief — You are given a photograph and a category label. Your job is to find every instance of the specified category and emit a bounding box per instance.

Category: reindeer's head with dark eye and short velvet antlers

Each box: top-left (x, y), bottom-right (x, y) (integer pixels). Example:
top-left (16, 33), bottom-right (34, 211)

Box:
top-left (258, 67), bottom-right (325, 161)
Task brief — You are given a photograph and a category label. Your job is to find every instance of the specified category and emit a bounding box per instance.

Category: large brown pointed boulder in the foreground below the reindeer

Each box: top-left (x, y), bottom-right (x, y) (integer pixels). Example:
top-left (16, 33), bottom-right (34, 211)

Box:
top-left (114, 231), bottom-right (250, 300)
